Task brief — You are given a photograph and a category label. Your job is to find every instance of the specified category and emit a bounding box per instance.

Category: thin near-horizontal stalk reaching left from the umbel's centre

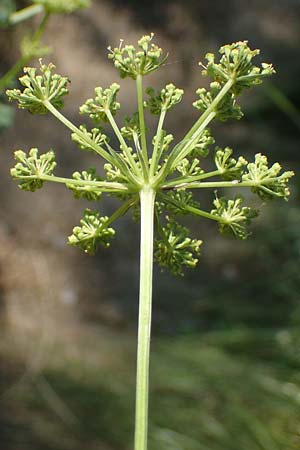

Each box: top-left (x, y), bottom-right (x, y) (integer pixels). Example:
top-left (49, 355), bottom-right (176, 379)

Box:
top-left (16, 174), bottom-right (128, 192)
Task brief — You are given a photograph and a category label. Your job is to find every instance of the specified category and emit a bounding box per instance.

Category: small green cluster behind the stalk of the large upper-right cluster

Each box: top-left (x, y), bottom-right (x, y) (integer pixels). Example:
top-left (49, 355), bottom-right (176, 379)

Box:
top-left (193, 81), bottom-right (243, 122)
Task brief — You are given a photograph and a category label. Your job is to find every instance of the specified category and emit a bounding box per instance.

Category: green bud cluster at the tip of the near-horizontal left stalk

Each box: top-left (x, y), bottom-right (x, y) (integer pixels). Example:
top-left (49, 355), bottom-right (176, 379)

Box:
top-left (10, 148), bottom-right (56, 192)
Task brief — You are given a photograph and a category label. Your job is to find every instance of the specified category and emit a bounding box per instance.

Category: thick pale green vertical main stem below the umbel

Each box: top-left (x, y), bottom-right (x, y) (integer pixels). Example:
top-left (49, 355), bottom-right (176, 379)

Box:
top-left (134, 186), bottom-right (155, 450)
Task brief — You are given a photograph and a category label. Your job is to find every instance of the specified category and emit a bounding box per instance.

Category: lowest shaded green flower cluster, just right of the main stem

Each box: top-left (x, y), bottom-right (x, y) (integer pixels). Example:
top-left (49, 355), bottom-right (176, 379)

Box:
top-left (154, 217), bottom-right (202, 275)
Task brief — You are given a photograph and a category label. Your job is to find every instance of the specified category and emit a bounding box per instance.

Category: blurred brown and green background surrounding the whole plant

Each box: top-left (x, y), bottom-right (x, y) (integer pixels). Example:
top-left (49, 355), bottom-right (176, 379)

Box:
top-left (0, 0), bottom-right (300, 450)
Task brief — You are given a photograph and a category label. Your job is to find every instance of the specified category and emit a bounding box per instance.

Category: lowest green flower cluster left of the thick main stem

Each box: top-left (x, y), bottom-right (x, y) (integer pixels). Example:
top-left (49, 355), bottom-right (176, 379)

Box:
top-left (68, 209), bottom-right (115, 255)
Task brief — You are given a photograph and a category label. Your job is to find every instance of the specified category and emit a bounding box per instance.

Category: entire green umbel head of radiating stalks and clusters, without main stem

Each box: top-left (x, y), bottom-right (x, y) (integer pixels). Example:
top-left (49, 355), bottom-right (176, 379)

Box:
top-left (8, 35), bottom-right (293, 275)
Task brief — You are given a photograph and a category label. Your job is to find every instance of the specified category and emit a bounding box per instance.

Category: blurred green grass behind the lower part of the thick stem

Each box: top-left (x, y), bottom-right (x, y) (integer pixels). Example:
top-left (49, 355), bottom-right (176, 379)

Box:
top-left (0, 329), bottom-right (300, 450)
